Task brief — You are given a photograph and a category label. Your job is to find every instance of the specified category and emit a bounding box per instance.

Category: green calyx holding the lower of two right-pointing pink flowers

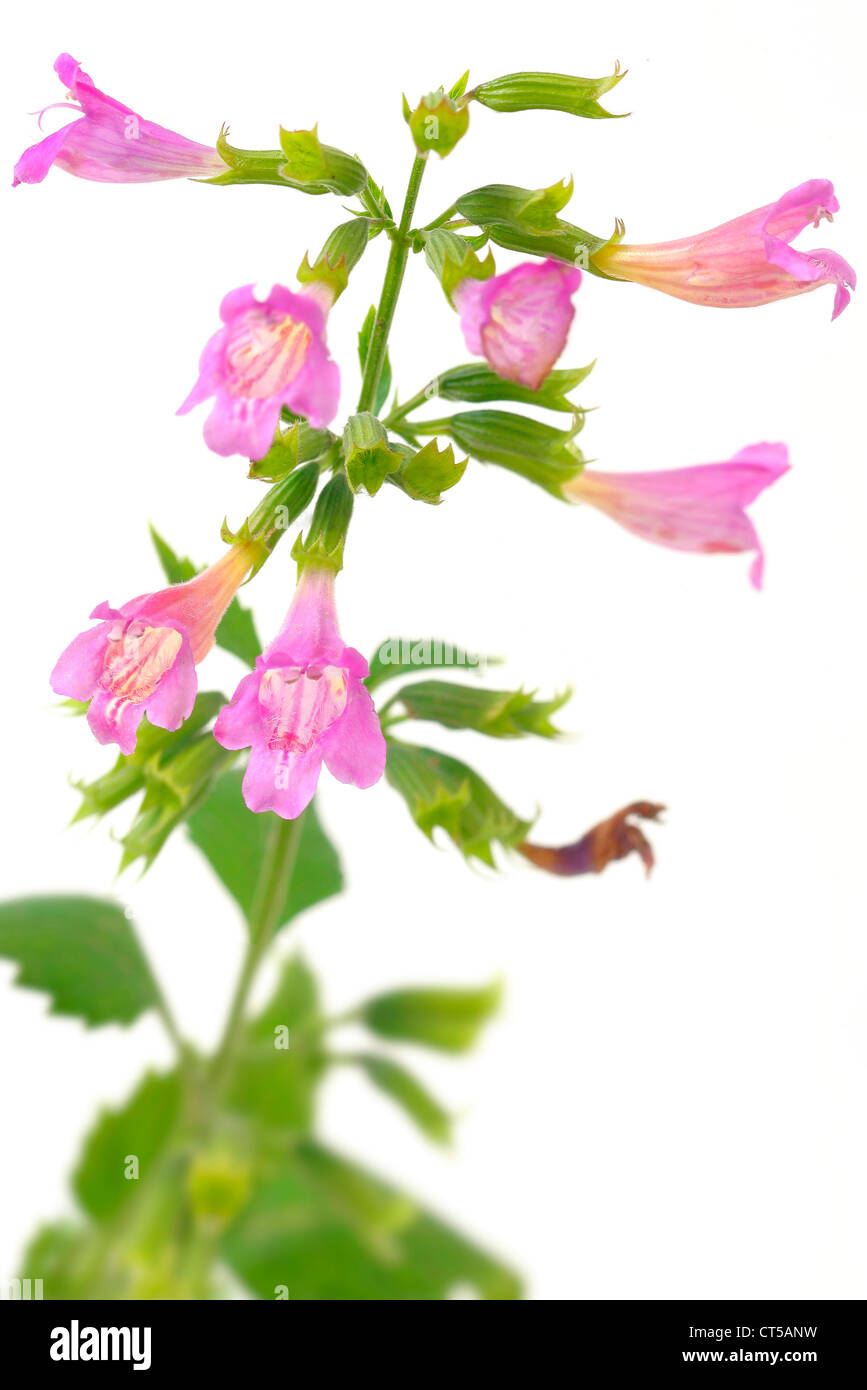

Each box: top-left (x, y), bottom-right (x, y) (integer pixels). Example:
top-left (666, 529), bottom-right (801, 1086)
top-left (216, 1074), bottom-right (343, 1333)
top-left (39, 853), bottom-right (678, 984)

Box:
top-left (436, 410), bottom-right (584, 499)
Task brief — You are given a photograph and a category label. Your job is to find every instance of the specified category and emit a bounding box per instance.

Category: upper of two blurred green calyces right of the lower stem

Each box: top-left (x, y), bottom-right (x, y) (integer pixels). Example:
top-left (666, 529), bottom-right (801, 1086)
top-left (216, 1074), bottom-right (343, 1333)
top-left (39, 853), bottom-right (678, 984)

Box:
top-left (358, 980), bottom-right (503, 1052)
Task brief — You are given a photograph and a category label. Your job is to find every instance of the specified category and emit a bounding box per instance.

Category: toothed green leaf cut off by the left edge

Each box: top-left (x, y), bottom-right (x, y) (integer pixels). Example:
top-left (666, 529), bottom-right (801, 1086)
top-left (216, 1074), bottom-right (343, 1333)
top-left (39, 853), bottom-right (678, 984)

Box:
top-left (0, 894), bottom-right (158, 1026)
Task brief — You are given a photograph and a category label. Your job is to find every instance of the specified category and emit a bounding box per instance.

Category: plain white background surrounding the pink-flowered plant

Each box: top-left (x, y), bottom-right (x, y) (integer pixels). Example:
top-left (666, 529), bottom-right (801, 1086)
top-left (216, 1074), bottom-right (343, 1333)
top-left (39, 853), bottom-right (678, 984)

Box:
top-left (0, 0), bottom-right (867, 1300)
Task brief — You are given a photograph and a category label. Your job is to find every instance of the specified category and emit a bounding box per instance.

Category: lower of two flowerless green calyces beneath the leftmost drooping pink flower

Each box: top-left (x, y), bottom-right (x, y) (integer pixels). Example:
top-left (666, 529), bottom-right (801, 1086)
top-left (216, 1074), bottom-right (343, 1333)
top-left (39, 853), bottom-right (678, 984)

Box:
top-left (121, 734), bottom-right (238, 872)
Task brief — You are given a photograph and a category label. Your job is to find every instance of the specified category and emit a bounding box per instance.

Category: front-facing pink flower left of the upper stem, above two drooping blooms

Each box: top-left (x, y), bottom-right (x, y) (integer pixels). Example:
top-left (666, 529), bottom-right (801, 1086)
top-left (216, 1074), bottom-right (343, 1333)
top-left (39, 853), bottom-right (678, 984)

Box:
top-left (178, 285), bottom-right (340, 459)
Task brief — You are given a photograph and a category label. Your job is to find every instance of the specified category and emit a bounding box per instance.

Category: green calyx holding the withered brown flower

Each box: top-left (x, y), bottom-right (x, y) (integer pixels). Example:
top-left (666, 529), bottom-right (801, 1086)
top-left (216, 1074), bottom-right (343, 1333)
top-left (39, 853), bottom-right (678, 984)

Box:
top-left (385, 738), bottom-right (532, 869)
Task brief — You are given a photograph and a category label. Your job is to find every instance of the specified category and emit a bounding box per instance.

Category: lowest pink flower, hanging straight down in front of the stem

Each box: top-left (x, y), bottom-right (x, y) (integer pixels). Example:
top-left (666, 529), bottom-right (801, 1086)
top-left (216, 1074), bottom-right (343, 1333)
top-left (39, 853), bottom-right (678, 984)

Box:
top-left (214, 566), bottom-right (385, 820)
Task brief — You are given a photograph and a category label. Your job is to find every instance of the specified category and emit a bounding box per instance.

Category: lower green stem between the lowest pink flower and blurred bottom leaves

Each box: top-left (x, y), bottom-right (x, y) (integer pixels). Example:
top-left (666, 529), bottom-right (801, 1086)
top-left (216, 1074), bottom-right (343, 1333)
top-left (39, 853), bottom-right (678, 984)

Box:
top-left (210, 813), bottom-right (304, 1094)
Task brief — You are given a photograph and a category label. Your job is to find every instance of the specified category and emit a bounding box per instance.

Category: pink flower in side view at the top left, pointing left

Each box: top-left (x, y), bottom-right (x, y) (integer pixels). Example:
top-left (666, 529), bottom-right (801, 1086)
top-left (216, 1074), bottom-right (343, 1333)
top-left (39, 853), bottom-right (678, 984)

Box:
top-left (13, 53), bottom-right (228, 186)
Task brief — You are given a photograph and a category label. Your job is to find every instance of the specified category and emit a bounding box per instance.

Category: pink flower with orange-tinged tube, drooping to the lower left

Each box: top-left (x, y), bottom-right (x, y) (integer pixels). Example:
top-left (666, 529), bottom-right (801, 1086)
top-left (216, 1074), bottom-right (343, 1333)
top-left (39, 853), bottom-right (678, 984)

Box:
top-left (51, 545), bottom-right (256, 753)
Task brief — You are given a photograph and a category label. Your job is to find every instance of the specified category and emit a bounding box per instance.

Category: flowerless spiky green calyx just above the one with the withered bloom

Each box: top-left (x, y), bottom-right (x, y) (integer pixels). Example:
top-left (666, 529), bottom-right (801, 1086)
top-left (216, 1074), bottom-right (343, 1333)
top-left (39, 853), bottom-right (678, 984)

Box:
top-left (393, 680), bottom-right (571, 738)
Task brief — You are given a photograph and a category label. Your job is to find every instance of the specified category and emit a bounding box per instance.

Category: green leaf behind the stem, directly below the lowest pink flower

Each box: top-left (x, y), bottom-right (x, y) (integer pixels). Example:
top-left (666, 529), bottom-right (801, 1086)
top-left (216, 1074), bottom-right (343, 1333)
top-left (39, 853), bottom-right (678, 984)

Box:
top-left (186, 771), bottom-right (343, 926)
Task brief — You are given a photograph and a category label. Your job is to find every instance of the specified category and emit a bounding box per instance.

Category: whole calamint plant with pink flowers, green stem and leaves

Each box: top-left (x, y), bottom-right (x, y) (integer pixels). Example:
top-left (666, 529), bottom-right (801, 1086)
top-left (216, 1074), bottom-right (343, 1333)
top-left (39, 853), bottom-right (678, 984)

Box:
top-left (0, 54), bottom-right (854, 1300)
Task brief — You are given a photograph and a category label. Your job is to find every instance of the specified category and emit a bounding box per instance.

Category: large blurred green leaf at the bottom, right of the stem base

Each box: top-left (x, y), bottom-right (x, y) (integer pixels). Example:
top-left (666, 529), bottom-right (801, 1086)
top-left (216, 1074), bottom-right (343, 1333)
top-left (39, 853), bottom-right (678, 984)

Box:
top-left (222, 1145), bottom-right (521, 1301)
